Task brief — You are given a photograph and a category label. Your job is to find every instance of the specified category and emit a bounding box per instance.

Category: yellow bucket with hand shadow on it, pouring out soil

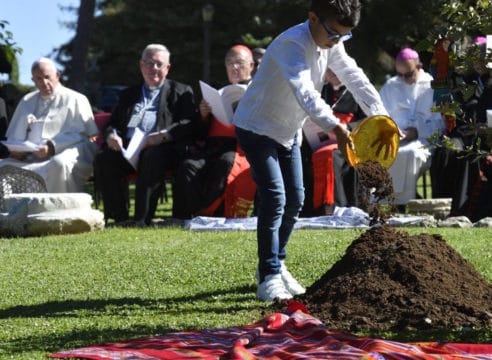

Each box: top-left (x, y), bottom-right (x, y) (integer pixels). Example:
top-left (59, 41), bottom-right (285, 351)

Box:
top-left (347, 115), bottom-right (400, 169)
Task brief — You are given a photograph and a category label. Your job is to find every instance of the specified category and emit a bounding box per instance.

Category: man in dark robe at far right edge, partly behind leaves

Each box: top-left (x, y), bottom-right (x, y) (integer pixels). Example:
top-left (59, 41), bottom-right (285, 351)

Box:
top-left (430, 37), bottom-right (492, 222)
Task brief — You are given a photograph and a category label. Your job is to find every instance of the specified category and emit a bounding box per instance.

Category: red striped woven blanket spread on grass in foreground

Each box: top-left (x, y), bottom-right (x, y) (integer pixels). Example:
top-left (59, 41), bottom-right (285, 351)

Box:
top-left (50, 310), bottom-right (492, 360)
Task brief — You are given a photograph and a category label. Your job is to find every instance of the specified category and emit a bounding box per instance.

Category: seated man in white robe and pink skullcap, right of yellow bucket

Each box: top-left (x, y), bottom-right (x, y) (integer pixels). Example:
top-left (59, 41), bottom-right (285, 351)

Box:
top-left (380, 48), bottom-right (444, 205)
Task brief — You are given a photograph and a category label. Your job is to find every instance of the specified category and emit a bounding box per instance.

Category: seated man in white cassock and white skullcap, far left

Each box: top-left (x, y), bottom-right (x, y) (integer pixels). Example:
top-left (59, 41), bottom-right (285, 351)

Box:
top-left (0, 58), bottom-right (97, 193)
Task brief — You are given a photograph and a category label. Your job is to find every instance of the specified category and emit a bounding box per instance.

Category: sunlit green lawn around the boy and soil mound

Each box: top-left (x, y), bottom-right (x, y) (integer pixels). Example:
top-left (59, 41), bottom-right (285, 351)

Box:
top-left (0, 228), bottom-right (492, 359)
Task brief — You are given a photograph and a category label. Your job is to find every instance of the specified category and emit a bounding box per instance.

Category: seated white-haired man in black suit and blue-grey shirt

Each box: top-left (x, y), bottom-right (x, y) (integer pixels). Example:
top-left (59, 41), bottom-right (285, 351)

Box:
top-left (95, 44), bottom-right (202, 225)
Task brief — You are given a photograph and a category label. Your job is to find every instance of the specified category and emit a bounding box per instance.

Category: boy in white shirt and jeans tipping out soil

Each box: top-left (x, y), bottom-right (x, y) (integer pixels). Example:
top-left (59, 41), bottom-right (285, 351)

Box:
top-left (234, 0), bottom-right (389, 301)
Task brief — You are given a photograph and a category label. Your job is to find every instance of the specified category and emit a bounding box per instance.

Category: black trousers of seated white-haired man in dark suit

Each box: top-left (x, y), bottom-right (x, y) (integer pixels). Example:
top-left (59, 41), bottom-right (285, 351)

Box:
top-left (94, 143), bottom-right (182, 224)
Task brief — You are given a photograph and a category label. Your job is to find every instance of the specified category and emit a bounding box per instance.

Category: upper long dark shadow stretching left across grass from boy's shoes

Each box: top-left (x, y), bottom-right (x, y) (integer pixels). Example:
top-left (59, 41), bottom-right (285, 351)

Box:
top-left (0, 285), bottom-right (256, 319)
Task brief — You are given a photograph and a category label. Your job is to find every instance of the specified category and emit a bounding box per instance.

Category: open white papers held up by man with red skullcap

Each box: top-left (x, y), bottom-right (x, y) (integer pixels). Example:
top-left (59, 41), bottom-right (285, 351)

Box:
top-left (199, 81), bottom-right (247, 125)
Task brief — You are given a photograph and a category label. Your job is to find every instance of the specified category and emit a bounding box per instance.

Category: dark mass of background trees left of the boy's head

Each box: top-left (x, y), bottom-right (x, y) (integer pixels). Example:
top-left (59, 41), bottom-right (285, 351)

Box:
top-left (52, 0), bottom-right (305, 105)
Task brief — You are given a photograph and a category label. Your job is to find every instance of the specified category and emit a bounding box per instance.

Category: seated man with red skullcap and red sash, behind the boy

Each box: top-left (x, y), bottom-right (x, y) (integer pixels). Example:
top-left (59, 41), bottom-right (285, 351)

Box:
top-left (173, 45), bottom-right (255, 219)
